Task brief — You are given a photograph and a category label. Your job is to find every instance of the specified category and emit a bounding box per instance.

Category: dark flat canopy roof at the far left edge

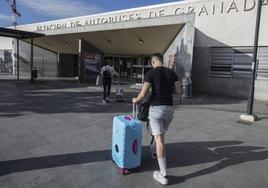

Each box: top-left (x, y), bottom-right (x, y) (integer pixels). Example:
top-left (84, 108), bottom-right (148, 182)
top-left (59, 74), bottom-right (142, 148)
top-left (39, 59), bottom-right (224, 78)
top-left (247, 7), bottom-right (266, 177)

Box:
top-left (0, 27), bottom-right (45, 39)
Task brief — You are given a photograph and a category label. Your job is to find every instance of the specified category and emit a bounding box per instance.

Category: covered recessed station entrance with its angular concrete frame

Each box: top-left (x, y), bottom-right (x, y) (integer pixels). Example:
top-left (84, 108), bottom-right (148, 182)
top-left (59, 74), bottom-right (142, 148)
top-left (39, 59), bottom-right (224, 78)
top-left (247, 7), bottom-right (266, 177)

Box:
top-left (15, 14), bottom-right (195, 82)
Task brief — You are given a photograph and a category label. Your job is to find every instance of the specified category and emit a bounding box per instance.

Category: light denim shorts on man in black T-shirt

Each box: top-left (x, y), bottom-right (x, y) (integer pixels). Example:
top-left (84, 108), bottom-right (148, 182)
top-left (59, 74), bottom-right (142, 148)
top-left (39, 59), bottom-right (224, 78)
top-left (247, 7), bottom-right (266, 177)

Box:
top-left (149, 106), bottom-right (174, 136)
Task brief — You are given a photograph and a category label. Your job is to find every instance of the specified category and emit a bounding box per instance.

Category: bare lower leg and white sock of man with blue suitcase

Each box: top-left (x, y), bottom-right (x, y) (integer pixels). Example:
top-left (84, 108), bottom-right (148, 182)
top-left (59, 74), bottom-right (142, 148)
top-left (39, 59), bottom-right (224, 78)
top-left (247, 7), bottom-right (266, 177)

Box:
top-left (154, 133), bottom-right (167, 176)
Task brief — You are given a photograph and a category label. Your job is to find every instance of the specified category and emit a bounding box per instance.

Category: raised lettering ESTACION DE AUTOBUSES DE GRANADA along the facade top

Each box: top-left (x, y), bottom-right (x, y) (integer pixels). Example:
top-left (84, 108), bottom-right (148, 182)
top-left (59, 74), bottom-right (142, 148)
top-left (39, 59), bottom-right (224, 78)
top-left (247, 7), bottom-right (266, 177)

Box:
top-left (36, 0), bottom-right (268, 31)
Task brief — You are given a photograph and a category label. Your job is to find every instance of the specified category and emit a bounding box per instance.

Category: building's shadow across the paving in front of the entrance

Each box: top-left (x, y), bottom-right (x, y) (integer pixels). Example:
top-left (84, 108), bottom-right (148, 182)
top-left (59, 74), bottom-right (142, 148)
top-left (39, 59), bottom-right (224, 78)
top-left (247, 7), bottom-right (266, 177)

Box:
top-left (0, 81), bottom-right (249, 118)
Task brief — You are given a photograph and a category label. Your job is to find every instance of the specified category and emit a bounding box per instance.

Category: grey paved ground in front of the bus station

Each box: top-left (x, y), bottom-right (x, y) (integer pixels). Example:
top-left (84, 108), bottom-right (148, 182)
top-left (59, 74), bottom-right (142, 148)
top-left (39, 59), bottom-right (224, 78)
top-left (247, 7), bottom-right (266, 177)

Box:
top-left (0, 81), bottom-right (268, 188)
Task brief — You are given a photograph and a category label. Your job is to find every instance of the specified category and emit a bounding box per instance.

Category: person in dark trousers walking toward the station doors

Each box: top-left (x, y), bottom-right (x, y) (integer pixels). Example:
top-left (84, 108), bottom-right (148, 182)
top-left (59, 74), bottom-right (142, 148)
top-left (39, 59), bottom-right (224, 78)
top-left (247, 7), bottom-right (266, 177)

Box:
top-left (101, 59), bottom-right (119, 103)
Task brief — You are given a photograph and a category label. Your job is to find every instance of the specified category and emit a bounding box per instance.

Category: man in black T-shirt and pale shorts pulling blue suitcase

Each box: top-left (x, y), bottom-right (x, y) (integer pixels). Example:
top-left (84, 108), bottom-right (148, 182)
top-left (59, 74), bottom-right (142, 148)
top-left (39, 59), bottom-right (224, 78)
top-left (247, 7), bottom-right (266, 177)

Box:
top-left (132, 53), bottom-right (181, 185)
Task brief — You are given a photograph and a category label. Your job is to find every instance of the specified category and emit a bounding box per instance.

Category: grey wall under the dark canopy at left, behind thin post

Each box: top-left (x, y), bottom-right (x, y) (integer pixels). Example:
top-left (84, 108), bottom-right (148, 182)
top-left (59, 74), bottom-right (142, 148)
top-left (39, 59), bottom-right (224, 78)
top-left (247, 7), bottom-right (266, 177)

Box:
top-left (14, 41), bottom-right (58, 79)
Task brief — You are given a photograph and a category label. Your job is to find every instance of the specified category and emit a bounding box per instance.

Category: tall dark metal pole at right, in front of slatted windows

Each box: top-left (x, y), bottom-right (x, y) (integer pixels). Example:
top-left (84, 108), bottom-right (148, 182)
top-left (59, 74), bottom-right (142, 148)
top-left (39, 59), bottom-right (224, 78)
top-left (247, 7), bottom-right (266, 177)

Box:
top-left (247, 0), bottom-right (262, 115)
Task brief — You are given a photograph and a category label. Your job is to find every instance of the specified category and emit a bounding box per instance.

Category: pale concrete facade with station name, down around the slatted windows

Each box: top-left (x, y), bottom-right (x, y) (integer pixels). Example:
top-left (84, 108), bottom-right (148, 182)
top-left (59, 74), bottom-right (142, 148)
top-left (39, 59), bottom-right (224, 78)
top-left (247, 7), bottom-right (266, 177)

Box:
top-left (0, 0), bottom-right (268, 100)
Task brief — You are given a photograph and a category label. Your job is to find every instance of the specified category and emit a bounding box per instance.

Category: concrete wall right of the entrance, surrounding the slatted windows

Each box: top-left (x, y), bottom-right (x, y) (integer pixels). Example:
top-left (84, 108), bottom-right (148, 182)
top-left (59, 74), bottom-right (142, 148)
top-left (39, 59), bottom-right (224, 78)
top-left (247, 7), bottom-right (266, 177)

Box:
top-left (186, 0), bottom-right (268, 100)
